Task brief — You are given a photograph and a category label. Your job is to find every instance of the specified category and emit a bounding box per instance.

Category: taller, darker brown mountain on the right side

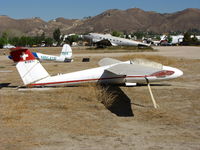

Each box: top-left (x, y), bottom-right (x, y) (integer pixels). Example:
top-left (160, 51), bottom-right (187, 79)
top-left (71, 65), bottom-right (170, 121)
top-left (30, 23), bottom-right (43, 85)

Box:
top-left (69, 8), bottom-right (200, 33)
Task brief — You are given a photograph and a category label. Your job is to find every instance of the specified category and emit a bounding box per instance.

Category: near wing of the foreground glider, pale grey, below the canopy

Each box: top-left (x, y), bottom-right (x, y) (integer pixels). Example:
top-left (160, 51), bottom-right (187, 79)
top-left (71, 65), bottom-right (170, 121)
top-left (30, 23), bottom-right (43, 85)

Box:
top-left (106, 64), bottom-right (161, 76)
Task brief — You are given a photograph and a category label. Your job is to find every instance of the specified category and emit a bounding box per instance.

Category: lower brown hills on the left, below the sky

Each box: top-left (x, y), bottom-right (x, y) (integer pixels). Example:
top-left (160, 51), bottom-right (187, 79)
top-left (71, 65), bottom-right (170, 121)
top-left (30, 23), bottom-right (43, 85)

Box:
top-left (0, 16), bottom-right (79, 36)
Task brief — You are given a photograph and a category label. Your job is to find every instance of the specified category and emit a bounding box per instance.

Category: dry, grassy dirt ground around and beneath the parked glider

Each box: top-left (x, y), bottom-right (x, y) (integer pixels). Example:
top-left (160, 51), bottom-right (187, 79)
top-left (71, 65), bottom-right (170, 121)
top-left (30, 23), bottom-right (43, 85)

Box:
top-left (0, 47), bottom-right (200, 150)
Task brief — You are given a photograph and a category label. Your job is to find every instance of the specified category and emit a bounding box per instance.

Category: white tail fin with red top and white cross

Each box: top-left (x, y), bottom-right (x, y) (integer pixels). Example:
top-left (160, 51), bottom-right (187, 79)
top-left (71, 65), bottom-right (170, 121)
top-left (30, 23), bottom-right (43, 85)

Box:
top-left (10, 47), bottom-right (49, 85)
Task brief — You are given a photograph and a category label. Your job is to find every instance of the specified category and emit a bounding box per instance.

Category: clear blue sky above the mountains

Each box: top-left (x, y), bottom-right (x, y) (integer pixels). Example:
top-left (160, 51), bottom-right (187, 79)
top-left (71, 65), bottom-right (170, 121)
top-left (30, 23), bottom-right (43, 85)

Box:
top-left (0, 0), bottom-right (200, 21)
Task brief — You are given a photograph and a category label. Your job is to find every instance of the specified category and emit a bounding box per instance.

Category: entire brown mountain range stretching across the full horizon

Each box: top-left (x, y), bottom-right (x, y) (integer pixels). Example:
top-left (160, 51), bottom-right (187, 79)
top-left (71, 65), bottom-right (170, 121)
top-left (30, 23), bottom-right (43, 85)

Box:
top-left (0, 8), bottom-right (200, 35)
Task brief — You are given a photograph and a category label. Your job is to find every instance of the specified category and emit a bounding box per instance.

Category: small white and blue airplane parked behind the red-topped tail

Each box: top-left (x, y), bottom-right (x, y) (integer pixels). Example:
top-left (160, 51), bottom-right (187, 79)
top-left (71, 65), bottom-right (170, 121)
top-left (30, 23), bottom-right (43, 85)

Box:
top-left (8, 44), bottom-right (73, 62)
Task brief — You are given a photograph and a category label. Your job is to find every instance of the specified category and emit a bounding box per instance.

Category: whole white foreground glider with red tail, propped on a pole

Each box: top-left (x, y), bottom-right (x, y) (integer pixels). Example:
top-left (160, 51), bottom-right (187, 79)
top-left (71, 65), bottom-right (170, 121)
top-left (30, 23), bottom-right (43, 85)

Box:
top-left (10, 48), bottom-right (183, 108)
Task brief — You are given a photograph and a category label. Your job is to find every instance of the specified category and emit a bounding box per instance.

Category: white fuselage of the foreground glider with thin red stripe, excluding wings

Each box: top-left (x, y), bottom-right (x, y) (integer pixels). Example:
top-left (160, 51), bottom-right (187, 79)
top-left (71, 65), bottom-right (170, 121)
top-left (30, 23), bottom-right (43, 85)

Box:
top-left (31, 61), bottom-right (183, 86)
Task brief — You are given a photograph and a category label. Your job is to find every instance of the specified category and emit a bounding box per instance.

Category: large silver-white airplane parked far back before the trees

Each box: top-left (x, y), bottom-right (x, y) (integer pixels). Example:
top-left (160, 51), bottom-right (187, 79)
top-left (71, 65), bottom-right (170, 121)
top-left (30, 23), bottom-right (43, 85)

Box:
top-left (83, 33), bottom-right (150, 47)
